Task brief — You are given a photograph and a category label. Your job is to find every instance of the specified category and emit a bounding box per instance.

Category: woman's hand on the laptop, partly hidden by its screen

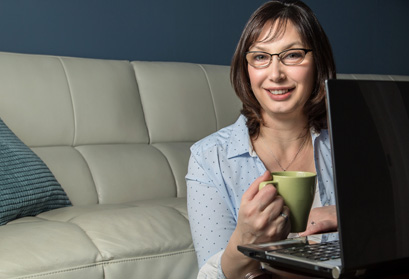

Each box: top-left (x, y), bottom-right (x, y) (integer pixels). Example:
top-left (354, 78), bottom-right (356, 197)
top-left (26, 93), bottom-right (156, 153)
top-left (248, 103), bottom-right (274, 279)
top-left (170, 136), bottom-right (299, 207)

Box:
top-left (299, 205), bottom-right (338, 236)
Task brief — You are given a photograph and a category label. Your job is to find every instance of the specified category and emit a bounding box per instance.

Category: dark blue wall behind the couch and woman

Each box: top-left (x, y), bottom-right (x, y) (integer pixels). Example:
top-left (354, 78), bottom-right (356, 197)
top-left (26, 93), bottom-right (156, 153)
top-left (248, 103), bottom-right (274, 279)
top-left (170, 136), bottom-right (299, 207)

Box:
top-left (0, 0), bottom-right (409, 75)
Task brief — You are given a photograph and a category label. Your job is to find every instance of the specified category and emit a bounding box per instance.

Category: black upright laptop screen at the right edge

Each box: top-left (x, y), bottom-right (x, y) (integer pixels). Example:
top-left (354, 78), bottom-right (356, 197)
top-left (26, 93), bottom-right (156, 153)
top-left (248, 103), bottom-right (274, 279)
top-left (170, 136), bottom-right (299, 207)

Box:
top-left (327, 80), bottom-right (409, 269)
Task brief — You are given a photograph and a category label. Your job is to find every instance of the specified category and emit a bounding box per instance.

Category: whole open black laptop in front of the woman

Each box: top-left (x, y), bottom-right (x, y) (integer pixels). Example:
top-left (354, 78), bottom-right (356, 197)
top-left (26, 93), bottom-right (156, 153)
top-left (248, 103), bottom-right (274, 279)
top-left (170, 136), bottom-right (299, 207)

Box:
top-left (238, 80), bottom-right (409, 278)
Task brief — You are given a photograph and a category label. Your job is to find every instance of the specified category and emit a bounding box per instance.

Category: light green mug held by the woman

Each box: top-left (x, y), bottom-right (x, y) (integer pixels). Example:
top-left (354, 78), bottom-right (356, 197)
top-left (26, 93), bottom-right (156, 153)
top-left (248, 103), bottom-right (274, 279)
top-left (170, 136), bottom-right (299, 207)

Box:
top-left (259, 171), bottom-right (317, 232)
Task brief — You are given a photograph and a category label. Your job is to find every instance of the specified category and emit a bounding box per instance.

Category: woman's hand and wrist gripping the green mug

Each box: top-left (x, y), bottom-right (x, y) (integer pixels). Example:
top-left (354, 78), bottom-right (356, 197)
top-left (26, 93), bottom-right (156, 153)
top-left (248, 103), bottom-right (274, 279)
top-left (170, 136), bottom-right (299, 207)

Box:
top-left (221, 171), bottom-right (291, 278)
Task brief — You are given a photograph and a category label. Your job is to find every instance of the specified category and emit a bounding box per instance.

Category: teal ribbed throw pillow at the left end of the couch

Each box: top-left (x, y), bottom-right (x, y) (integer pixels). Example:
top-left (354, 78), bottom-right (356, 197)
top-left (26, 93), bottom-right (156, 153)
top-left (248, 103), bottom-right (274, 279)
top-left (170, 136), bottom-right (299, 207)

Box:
top-left (0, 119), bottom-right (71, 225)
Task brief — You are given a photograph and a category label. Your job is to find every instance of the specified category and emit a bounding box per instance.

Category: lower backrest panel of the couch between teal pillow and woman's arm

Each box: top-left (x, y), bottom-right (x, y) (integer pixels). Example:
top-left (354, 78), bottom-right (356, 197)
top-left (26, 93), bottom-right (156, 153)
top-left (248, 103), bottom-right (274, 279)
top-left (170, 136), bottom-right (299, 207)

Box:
top-left (77, 144), bottom-right (176, 204)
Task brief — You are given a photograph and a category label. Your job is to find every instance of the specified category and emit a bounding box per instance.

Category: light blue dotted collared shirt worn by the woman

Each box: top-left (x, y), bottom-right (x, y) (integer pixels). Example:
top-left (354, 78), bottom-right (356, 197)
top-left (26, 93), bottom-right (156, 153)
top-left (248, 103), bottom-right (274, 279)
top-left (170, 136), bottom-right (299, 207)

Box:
top-left (186, 115), bottom-right (335, 267)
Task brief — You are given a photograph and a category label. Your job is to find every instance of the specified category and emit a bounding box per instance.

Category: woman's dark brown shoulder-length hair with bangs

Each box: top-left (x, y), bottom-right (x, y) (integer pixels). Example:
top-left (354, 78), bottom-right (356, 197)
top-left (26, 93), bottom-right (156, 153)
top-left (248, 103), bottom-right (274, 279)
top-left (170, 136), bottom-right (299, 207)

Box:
top-left (230, 1), bottom-right (336, 138)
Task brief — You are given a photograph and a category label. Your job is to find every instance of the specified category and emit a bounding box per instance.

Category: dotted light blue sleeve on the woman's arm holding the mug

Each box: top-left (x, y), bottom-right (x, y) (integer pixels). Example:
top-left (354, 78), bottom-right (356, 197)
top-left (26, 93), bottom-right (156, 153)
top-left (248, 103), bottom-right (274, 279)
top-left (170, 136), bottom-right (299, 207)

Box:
top-left (186, 154), bottom-right (236, 278)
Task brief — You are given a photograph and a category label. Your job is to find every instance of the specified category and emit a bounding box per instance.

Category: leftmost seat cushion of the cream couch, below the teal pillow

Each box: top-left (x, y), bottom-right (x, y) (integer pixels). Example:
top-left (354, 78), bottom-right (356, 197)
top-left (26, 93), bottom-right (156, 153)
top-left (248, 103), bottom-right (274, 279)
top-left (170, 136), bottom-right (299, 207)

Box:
top-left (0, 221), bottom-right (104, 279)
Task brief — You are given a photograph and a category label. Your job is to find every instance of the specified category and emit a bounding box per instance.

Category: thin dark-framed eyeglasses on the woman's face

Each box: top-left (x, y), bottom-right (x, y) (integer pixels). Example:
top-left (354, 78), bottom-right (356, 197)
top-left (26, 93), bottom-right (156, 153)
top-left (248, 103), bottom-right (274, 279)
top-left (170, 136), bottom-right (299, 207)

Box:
top-left (245, 48), bottom-right (312, 68)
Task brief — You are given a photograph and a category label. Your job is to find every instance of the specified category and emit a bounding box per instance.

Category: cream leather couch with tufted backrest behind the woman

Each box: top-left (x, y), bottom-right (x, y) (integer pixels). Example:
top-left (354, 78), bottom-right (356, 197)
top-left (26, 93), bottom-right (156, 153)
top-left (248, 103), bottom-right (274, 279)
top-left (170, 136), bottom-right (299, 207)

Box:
top-left (0, 53), bottom-right (240, 279)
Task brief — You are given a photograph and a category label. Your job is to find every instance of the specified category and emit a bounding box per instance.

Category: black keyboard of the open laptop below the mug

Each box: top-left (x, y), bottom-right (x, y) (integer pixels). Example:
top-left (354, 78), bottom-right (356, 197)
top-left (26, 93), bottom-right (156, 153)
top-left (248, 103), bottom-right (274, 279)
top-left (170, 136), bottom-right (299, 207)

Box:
top-left (274, 240), bottom-right (341, 261)
